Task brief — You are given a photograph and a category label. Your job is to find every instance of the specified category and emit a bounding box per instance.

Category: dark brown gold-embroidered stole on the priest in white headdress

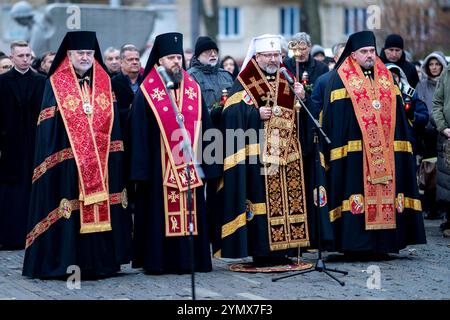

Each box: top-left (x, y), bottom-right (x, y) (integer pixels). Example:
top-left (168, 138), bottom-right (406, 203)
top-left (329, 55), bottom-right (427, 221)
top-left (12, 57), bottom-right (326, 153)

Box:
top-left (238, 59), bottom-right (309, 250)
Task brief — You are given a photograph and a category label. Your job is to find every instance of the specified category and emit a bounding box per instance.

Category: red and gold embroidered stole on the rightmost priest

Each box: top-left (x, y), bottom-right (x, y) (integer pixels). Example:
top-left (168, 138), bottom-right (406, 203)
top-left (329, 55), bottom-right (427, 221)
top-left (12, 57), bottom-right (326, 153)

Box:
top-left (338, 57), bottom-right (396, 230)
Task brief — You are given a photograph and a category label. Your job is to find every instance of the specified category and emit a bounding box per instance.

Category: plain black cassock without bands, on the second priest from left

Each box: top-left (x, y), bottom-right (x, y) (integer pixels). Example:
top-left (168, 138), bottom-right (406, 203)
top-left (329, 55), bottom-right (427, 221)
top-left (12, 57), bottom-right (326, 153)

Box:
top-left (127, 75), bottom-right (220, 274)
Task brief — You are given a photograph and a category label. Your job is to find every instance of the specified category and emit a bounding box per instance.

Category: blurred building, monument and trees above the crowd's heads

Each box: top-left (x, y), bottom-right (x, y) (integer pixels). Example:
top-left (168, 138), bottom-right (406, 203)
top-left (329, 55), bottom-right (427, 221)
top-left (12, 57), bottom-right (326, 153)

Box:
top-left (0, 0), bottom-right (450, 61)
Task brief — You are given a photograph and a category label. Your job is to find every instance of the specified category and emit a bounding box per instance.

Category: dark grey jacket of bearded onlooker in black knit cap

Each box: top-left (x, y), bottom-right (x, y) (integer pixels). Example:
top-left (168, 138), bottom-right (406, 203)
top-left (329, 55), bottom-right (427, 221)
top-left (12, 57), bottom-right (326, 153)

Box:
top-left (188, 57), bottom-right (233, 112)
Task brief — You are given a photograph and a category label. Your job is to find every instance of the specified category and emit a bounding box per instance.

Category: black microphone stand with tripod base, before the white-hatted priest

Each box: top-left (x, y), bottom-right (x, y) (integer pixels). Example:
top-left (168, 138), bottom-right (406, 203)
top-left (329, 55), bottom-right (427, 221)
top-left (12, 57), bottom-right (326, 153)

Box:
top-left (272, 81), bottom-right (348, 286)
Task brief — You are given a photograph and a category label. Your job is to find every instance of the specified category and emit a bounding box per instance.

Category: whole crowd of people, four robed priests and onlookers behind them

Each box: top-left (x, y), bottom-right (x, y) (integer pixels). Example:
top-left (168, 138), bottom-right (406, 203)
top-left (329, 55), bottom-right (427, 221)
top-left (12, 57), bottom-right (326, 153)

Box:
top-left (0, 31), bottom-right (450, 278)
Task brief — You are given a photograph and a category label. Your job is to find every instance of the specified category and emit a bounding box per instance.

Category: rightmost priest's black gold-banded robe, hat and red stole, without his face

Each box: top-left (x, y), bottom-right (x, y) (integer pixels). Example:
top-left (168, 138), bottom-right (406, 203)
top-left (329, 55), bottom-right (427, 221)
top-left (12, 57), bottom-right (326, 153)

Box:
top-left (323, 31), bottom-right (426, 254)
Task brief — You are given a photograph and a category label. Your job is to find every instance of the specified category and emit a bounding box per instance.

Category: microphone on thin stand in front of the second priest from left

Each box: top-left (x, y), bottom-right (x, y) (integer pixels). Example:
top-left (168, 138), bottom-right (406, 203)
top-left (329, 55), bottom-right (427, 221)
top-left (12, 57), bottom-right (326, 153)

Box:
top-left (163, 81), bottom-right (199, 300)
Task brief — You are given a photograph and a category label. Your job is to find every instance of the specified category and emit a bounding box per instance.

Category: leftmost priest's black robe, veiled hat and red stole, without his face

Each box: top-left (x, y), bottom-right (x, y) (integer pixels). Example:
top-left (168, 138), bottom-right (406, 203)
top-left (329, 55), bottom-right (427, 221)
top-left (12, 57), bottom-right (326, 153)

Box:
top-left (23, 32), bottom-right (131, 278)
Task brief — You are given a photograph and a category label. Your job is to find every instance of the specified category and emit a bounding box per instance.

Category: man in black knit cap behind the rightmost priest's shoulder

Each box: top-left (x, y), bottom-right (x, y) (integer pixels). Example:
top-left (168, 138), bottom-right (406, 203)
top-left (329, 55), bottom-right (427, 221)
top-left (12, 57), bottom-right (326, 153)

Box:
top-left (380, 34), bottom-right (419, 88)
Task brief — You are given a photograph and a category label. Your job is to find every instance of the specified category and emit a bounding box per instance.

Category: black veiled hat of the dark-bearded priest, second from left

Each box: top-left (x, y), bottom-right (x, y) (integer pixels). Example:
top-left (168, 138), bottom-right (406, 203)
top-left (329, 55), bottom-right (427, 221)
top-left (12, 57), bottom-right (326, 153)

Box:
top-left (144, 32), bottom-right (186, 78)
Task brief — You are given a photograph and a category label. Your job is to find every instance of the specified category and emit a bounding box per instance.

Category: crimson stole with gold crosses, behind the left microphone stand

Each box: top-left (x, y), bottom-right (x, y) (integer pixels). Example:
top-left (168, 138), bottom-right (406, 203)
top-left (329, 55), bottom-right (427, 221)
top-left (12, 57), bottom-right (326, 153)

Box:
top-left (141, 66), bottom-right (203, 237)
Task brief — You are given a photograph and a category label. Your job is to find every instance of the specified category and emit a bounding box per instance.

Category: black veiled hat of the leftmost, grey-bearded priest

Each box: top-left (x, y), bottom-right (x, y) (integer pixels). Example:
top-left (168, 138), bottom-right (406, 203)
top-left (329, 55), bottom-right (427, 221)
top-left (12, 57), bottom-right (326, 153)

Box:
top-left (48, 31), bottom-right (108, 77)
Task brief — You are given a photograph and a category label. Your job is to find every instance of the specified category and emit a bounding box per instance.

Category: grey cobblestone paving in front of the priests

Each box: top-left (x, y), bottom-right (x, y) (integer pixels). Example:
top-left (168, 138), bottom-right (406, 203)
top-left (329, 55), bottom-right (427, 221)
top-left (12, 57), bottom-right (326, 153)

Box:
top-left (0, 221), bottom-right (450, 300)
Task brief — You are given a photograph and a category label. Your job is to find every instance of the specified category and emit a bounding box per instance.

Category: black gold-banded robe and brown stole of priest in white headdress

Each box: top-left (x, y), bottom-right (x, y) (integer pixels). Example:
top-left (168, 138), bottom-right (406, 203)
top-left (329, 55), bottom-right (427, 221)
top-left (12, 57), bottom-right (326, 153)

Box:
top-left (213, 58), bottom-right (332, 265)
